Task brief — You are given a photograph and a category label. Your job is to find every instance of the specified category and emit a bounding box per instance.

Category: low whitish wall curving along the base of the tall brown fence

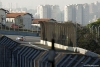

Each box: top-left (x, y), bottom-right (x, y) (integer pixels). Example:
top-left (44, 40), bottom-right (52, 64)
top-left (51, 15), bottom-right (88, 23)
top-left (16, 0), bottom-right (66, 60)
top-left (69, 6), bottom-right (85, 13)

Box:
top-left (40, 40), bottom-right (98, 57)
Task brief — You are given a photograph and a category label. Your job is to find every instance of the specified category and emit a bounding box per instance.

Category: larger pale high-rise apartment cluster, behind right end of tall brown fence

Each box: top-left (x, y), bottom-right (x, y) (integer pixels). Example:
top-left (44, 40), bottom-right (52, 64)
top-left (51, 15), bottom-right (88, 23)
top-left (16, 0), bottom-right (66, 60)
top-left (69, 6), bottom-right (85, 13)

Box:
top-left (64, 4), bottom-right (89, 25)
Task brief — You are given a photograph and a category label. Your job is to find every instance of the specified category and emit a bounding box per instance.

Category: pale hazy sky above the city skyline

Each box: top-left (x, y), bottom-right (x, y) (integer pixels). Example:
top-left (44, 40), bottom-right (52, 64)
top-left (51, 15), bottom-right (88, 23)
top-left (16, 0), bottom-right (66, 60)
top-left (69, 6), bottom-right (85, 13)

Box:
top-left (0, 0), bottom-right (100, 9)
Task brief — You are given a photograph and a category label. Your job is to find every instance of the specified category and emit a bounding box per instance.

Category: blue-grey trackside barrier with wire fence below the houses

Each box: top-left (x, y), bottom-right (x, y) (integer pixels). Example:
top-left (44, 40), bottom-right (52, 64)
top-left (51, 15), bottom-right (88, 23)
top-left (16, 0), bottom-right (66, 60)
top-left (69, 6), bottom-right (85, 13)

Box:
top-left (0, 26), bottom-right (40, 36)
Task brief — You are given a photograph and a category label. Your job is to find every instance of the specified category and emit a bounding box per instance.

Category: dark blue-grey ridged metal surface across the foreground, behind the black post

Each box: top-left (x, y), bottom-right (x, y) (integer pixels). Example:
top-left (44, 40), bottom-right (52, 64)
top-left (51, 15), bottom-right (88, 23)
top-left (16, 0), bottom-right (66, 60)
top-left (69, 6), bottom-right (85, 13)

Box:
top-left (0, 36), bottom-right (100, 67)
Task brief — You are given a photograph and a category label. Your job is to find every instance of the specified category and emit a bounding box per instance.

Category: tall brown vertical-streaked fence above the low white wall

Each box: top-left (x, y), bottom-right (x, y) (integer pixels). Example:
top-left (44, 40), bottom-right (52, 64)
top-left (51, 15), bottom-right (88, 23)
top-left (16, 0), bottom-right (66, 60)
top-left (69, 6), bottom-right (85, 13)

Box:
top-left (40, 22), bottom-right (76, 47)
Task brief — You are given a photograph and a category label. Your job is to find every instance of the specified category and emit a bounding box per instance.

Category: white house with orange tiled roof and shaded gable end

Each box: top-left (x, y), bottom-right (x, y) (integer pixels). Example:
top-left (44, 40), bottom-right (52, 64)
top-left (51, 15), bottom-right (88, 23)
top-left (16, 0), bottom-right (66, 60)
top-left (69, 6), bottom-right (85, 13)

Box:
top-left (6, 13), bottom-right (33, 29)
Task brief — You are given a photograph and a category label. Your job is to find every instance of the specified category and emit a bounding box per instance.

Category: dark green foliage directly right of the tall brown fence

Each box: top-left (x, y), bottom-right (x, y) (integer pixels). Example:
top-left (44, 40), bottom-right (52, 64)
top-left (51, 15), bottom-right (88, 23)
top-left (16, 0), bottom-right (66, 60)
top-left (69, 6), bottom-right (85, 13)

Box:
top-left (77, 27), bottom-right (100, 54)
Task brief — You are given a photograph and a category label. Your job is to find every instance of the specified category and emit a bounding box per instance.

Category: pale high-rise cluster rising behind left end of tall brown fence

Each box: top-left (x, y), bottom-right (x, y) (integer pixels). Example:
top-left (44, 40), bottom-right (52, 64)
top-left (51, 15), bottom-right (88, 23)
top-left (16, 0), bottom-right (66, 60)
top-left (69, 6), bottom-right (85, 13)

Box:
top-left (35, 5), bottom-right (62, 21)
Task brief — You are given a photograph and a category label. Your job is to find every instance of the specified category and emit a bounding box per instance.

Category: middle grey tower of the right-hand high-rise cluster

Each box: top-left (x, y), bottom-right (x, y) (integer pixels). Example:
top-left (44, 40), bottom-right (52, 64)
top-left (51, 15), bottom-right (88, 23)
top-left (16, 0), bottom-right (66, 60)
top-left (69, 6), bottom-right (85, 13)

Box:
top-left (76, 4), bottom-right (83, 24)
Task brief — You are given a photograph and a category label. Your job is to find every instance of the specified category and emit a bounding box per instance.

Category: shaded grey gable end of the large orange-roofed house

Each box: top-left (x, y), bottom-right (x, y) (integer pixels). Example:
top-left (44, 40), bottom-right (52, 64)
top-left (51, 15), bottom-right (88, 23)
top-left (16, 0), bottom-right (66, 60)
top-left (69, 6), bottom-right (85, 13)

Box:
top-left (15, 13), bottom-right (32, 29)
